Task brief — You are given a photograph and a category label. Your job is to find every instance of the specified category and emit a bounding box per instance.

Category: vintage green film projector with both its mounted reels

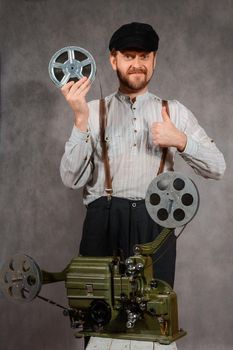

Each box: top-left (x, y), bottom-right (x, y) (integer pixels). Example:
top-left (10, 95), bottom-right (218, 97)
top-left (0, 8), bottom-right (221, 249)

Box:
top-left (0, 171), bottom-right (199, 344)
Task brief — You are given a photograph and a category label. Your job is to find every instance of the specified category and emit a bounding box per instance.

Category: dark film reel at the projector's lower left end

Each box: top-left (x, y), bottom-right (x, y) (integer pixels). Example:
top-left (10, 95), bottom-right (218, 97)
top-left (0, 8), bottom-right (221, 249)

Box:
top-left (0, 254), bottom-right (42, 302)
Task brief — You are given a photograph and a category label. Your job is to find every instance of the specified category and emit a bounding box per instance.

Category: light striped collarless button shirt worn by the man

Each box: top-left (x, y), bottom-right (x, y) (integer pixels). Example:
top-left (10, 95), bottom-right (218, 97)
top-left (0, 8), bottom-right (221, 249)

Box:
top-left (60, 91), bottom-right (225, 205)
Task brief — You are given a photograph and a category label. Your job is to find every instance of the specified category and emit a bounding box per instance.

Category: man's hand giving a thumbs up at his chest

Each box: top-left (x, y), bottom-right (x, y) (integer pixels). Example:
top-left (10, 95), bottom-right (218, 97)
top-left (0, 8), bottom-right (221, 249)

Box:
top-left (151, 106), bottom-right (187, 152)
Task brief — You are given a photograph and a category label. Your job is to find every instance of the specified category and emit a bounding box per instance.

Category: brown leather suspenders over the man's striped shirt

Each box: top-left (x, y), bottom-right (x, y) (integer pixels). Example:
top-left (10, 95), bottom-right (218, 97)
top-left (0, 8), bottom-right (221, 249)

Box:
top-left (99, 98), bottom-right (170, 199)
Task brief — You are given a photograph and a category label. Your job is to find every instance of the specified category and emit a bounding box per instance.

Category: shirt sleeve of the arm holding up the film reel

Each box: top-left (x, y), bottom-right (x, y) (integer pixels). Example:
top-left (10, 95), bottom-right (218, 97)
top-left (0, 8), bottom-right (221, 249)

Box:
top-left (60, 126), bottom-right (93, 188)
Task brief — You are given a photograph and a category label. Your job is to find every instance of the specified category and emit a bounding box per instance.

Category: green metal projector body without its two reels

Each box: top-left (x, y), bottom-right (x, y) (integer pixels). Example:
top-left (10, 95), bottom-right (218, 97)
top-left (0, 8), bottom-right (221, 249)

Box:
top-left (63, 229), bottom-right (186, 344)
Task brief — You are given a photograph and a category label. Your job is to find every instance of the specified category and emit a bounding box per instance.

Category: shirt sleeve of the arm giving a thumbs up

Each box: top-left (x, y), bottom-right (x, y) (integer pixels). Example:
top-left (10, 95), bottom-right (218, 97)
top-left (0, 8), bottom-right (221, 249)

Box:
top-left (177, 102), bottom-right (226, 180)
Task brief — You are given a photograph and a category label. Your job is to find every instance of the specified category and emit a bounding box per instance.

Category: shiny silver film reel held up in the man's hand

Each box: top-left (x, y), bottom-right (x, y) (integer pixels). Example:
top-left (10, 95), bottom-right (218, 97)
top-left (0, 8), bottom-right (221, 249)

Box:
top-left (48, 46), bottom-right (96, 88)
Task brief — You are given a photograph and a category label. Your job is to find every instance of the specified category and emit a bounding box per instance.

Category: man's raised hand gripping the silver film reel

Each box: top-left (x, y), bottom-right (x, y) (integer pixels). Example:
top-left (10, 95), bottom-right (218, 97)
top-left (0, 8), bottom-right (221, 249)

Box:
top-left (61, 77), bottom-right (91, 131)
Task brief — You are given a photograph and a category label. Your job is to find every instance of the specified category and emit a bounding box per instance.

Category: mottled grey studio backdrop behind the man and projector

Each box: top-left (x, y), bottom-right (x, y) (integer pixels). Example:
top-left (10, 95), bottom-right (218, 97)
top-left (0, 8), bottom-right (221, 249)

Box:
top-left (0, 0), bottom-right (233, 350)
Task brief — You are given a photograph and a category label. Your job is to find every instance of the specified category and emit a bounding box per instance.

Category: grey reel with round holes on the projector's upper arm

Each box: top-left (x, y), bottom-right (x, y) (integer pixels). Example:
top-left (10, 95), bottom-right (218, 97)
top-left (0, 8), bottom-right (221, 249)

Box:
top-left (146, 171), bottom-right (199, 228)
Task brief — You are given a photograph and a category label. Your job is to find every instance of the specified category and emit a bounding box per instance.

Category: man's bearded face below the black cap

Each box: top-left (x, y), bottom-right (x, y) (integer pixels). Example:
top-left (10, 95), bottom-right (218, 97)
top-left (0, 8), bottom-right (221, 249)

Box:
top-left (110, 50), bottom-right (156, 92)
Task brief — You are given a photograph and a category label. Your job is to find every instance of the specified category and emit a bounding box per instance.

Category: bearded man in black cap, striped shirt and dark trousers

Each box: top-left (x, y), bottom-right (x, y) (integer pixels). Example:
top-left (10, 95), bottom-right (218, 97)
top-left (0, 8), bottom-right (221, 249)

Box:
top-left (60, 22), bottom-right (225, 287)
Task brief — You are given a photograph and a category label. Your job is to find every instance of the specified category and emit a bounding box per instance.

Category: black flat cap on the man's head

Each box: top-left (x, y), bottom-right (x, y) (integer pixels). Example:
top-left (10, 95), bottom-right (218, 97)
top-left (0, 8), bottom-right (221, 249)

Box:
top-left (109, 22), bottom-right (159, 52)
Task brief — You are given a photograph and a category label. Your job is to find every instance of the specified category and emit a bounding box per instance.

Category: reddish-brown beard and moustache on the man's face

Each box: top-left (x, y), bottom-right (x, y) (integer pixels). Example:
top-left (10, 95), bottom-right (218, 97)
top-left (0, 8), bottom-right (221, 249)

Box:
top-left (117, 67), bottom-right (152, 92)
